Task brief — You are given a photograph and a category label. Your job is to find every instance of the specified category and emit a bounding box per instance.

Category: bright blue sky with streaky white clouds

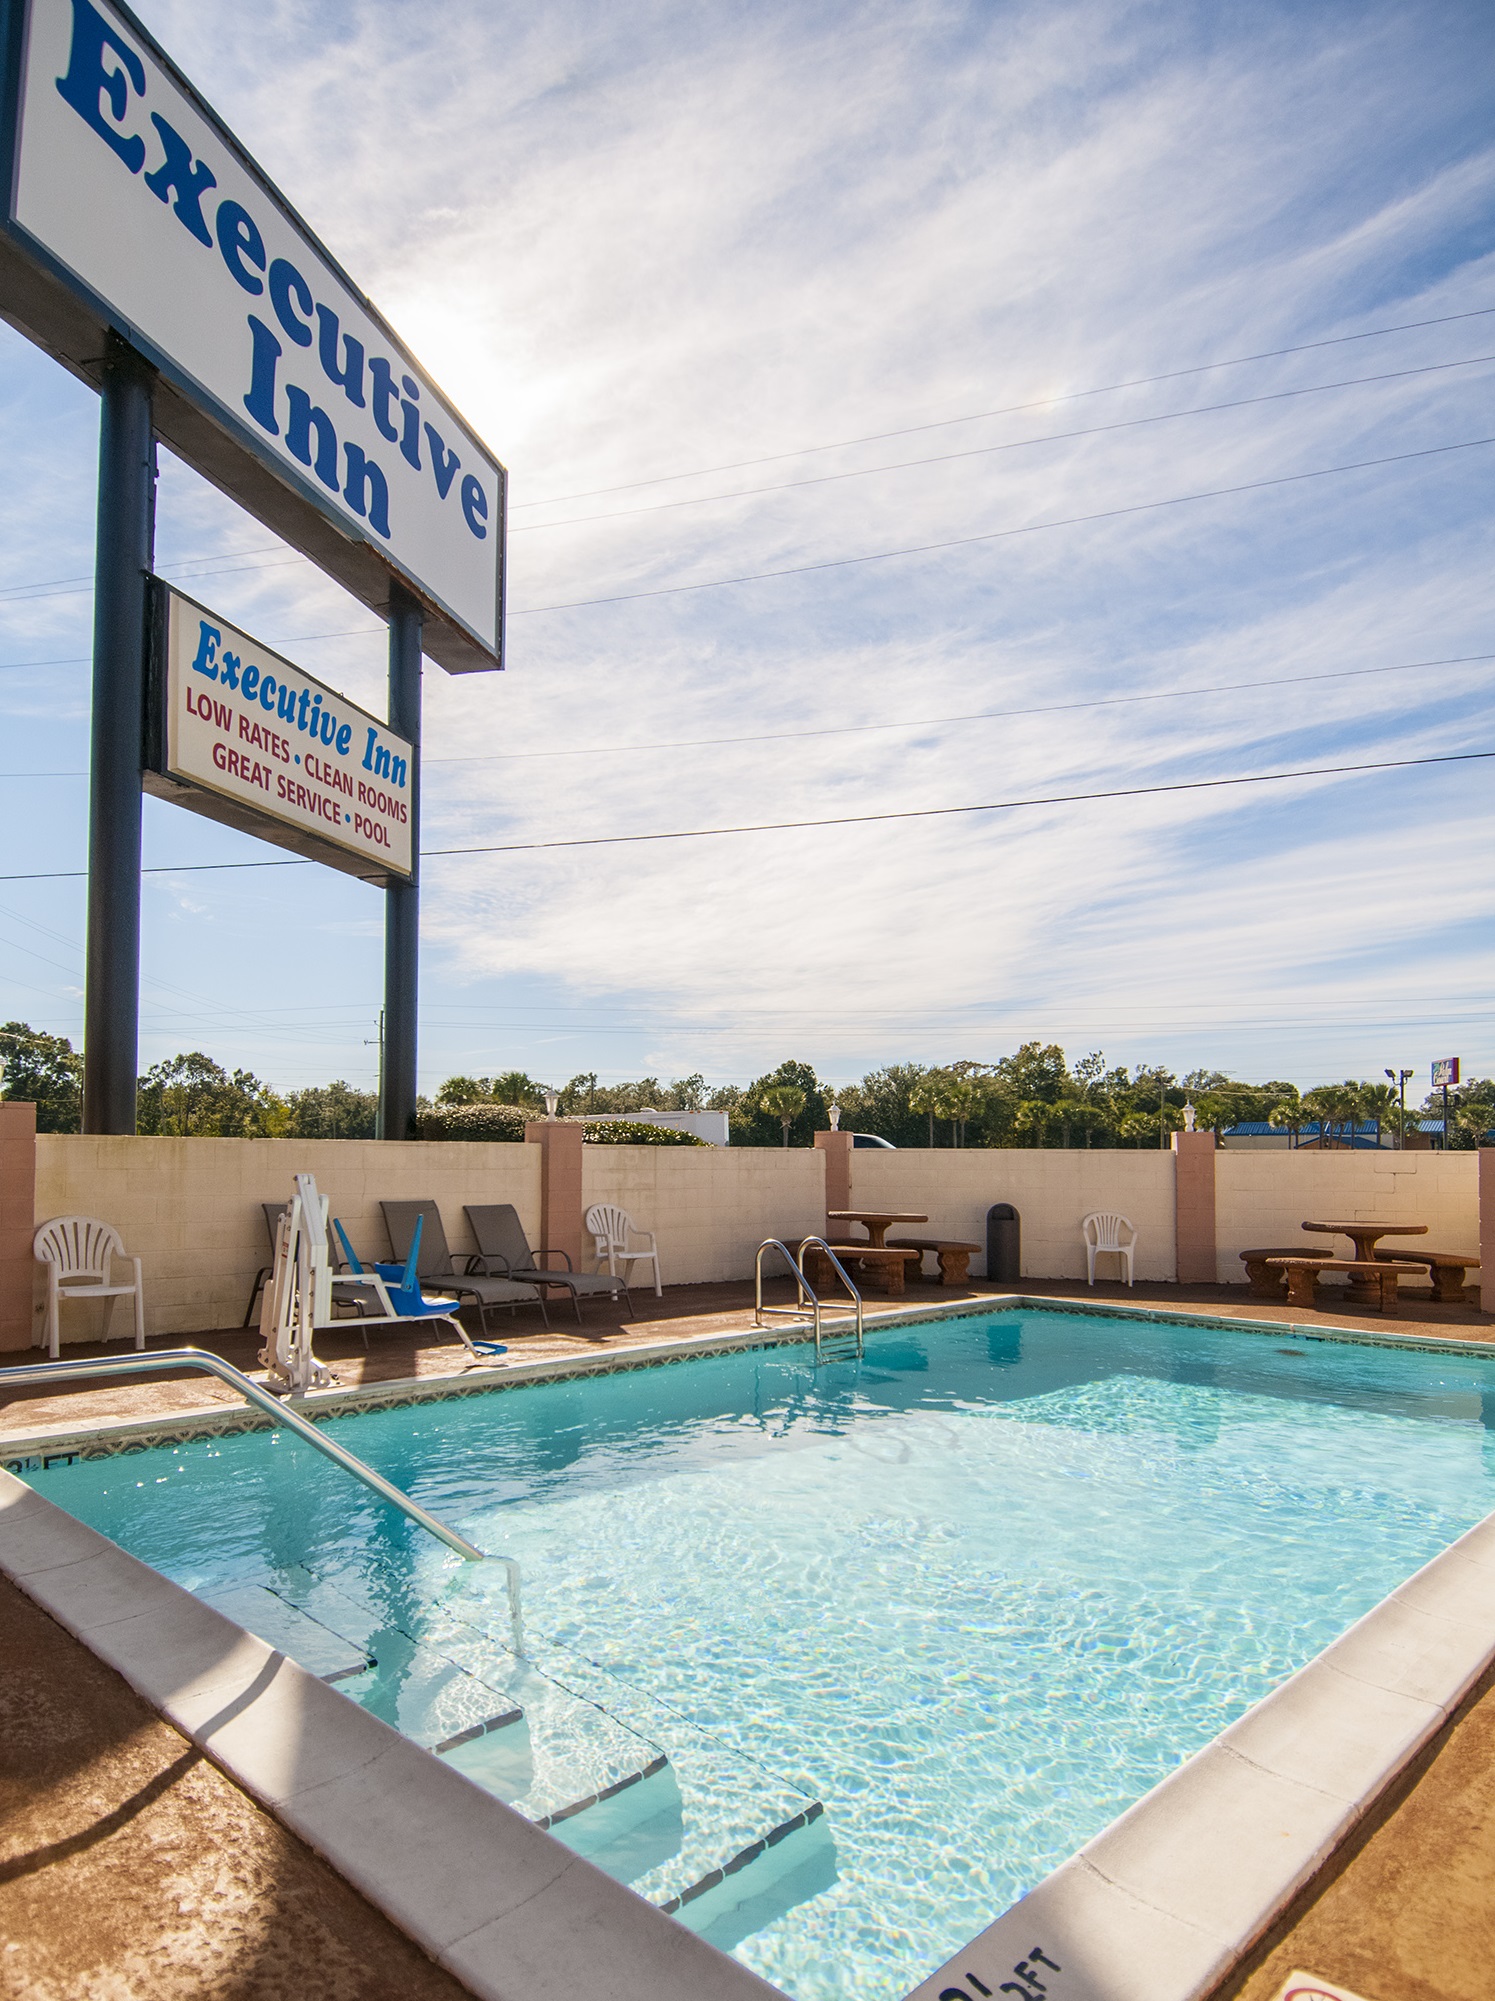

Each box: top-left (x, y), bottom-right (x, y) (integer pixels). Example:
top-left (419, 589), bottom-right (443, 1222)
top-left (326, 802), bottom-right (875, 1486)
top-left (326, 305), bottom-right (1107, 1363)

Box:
top-left (0, 0), bottom-right (1495, 1091)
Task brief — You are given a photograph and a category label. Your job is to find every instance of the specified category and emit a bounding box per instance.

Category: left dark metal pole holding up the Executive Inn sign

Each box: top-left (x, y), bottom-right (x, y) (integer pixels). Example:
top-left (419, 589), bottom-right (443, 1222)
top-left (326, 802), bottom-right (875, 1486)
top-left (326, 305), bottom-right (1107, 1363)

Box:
top-left (82, 336), bottom-right (156, 1133)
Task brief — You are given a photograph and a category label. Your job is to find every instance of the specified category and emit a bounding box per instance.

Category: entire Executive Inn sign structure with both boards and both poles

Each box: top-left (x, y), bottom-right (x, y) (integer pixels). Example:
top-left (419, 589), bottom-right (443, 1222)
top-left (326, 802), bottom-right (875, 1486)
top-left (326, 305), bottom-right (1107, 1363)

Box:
top-left (0, 0), bottom-right (506, 1137)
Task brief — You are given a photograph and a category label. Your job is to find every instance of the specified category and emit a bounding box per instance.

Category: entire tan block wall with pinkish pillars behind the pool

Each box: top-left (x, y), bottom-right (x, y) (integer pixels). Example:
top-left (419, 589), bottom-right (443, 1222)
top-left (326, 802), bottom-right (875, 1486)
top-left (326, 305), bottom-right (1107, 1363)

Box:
top-left (20, 1128), bottom-right (1495, 1347)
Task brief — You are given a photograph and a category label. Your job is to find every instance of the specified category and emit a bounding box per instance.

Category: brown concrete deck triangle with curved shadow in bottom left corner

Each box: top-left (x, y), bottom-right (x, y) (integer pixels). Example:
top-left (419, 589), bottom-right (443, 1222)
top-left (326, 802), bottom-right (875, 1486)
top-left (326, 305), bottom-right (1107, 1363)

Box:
top-left (0, 1577), bottom-right (482, 2001)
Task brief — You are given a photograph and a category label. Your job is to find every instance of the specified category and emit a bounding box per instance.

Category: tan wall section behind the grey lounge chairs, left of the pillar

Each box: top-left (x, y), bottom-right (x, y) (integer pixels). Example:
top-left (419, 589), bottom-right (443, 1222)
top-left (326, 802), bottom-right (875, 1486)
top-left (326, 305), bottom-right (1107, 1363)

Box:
top-left (36, 1133), bottom-right (540, 1343)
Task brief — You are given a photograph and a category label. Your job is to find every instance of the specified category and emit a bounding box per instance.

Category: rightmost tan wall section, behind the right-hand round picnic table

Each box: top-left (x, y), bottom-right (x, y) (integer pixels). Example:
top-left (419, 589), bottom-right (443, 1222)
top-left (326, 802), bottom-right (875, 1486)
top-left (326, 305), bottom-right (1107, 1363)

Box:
top-left (1215, 1147), bottom-right (1479, 1285)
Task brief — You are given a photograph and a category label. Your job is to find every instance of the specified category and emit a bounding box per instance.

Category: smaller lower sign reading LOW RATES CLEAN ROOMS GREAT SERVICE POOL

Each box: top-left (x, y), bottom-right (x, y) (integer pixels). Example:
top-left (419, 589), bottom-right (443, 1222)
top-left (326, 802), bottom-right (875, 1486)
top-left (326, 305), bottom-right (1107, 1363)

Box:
top-left (142, 578), bottom-right (420, 884)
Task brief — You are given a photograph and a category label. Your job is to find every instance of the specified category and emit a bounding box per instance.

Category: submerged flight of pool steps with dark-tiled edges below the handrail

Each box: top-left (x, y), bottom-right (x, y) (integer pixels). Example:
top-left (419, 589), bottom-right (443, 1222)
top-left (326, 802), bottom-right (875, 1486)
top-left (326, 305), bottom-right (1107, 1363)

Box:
top-left (200, 1553), bottom-right (837, 1951)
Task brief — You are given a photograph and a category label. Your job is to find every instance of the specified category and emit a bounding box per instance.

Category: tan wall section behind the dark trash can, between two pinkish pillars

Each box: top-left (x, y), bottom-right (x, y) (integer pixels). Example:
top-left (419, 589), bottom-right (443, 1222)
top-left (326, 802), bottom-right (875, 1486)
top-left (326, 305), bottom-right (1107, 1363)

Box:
top-left (851, 1147), bottom-right (1175, 1279)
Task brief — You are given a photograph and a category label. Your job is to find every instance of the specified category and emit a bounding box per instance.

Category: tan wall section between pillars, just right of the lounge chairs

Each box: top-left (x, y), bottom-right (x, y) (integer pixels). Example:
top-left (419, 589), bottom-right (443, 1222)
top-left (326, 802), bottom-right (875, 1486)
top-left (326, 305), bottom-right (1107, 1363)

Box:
top-left (580, 1147), bottom-right (825, 1285)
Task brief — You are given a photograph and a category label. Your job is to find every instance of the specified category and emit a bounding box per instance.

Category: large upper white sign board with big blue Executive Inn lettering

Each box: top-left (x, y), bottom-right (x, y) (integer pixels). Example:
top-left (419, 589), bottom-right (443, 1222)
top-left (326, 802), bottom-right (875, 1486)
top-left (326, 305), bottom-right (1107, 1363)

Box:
top-left (0, 0), bottom-right (508, 672)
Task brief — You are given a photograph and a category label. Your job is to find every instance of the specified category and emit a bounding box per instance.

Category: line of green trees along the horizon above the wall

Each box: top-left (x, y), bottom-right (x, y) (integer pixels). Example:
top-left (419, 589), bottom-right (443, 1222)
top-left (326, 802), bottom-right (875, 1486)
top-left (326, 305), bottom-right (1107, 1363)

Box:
top-left (0, 1021), bottom-right (1495, 1151)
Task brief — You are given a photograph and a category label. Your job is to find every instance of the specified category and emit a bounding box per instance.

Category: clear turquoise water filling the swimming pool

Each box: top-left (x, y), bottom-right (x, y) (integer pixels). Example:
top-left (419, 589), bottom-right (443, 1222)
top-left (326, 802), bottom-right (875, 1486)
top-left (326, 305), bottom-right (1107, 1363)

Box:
top-left (28, 1313), bottom-right (1495, 2001)
